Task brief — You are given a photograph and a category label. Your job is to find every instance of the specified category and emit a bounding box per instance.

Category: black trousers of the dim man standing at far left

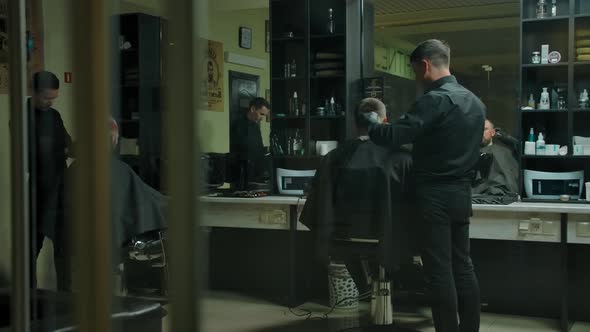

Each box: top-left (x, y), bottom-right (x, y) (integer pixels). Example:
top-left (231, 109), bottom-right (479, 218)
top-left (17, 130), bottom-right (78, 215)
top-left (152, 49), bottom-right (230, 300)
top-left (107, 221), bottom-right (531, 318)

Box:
top-left (30, 233), bottom-right (72, 291)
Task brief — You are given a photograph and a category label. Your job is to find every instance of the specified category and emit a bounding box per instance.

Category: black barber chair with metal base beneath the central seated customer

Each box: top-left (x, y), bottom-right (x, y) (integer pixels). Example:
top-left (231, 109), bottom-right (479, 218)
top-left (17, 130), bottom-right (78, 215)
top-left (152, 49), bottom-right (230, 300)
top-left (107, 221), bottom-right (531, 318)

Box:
top-left (329, 168), bottom-right (414, 332)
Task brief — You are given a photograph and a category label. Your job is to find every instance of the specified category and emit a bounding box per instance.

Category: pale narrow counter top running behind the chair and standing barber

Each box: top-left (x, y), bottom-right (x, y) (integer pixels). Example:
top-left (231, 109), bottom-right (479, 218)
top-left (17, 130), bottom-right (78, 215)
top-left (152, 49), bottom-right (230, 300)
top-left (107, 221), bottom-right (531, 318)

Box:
top-left (201, 196), bottom-right (590, 214)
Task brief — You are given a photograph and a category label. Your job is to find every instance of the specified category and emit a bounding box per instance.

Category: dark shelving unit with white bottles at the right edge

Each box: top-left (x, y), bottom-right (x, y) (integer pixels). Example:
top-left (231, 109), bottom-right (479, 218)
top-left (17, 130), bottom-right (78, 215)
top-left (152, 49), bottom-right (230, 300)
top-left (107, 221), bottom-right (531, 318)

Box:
top-left (518, 0), bottom-right (590, 200)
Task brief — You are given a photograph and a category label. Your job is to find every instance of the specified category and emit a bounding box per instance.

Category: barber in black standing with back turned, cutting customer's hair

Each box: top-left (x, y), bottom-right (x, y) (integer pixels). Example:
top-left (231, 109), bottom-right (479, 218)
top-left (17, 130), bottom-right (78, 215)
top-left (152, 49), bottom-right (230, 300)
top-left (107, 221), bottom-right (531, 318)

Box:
top-left (370, 39), bottom-right (486, 332)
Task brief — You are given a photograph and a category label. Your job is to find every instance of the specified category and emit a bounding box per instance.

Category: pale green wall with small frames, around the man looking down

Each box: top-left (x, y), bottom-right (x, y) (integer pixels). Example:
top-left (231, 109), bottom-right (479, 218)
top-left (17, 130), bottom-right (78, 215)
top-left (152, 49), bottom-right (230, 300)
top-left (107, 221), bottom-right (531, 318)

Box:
top-left (198, 8), bottom-right (270, 152)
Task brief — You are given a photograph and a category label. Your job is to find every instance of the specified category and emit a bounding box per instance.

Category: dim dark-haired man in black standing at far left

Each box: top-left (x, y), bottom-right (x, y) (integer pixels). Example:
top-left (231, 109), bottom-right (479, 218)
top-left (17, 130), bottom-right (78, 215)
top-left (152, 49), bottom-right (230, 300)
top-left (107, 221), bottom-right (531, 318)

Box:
top-left (28, 71), bottom-right (72, 290)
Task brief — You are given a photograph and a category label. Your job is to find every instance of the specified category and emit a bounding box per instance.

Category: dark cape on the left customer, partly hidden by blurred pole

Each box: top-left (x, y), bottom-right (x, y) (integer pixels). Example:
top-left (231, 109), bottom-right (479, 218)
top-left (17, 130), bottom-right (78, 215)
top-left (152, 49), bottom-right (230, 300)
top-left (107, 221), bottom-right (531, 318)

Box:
top-left (67, 157), bottom-right (168, 252)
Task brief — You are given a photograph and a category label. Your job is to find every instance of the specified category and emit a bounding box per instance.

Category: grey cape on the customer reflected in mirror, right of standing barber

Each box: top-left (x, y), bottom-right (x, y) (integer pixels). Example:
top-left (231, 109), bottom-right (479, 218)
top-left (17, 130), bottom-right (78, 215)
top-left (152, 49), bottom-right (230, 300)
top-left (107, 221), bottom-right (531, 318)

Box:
top-left (472, 143), bottom-right (518, 195)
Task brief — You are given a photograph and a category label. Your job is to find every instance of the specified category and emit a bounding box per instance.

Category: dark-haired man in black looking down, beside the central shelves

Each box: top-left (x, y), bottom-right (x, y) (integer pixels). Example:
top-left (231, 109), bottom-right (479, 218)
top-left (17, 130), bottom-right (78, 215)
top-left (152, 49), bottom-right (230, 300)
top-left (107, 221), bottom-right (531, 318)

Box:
top-left (230, 97), bottom-right (270, 185)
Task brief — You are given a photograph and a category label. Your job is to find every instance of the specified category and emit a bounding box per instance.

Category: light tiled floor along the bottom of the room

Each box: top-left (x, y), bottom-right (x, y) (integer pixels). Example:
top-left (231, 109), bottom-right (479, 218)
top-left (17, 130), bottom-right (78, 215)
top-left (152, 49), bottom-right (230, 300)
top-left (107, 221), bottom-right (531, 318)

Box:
top-left (164, 293), bottom-right (590, 332)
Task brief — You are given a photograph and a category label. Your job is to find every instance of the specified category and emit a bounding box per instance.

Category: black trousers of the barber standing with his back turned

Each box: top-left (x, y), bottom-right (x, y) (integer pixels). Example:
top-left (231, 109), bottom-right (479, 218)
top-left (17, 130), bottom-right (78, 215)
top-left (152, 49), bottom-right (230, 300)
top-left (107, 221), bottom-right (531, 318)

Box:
top-left (416, 184), bottom-right (480, 332)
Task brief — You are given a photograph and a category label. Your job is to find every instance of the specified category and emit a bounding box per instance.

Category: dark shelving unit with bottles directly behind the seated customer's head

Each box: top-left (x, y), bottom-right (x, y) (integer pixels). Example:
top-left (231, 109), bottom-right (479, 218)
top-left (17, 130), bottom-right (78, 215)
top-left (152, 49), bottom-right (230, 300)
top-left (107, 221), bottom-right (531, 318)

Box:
top-left (270, 0), bottom-right (361, 194)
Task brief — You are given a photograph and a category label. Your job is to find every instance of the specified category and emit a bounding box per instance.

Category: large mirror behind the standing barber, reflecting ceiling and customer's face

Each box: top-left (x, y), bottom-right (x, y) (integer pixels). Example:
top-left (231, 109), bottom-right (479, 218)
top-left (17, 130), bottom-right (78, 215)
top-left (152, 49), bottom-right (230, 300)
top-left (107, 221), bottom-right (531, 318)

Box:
top-left (374, 0), bottom-right (520, 196)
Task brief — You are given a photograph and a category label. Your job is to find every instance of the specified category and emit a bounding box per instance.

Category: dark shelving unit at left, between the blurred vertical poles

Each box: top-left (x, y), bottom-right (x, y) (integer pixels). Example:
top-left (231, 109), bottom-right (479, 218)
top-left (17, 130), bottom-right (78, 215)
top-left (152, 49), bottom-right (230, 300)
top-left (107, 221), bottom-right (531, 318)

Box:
top-left (113, 14), bottom-right (164, 190)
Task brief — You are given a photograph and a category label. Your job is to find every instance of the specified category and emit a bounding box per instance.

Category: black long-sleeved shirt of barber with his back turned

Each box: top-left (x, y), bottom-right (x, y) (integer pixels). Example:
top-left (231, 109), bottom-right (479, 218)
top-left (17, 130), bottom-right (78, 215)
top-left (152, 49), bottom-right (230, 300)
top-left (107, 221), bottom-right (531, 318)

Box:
top-left (370, 76), bottom-right (486, 182)
